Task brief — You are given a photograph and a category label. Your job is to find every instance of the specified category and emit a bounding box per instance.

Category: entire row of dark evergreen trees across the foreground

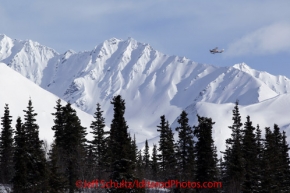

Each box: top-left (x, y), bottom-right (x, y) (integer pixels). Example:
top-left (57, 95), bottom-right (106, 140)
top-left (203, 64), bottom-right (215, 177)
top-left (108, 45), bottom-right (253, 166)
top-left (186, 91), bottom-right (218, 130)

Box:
top-left (0, 95), bottom-right (290, 193)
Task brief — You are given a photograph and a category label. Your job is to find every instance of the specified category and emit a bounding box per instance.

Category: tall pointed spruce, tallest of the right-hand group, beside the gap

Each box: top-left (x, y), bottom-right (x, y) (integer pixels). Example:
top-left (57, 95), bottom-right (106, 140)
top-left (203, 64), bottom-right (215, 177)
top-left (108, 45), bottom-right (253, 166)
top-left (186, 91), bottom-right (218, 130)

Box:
top-left (222, 101), bottom-right (244, 192)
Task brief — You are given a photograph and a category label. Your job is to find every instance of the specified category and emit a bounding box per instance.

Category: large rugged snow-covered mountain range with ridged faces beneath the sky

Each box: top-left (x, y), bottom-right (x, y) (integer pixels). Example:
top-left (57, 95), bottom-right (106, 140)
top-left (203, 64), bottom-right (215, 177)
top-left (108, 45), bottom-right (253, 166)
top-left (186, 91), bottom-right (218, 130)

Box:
top-left (0, 35), bottom-right (290, 152)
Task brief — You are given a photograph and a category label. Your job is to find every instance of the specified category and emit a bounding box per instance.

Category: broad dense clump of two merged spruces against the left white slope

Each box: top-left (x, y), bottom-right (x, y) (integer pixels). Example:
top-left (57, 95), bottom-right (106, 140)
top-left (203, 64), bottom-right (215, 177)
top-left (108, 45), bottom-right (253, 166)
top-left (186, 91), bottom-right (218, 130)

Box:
top-left (49, 100), bottom-right (87, 193)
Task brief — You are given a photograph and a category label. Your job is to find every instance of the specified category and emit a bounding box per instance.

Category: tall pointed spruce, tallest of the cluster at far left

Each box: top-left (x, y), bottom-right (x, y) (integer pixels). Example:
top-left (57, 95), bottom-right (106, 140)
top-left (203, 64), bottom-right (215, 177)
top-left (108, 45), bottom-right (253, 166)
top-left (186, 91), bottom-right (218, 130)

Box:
top-left (23, 100), bottom-right (48, 192)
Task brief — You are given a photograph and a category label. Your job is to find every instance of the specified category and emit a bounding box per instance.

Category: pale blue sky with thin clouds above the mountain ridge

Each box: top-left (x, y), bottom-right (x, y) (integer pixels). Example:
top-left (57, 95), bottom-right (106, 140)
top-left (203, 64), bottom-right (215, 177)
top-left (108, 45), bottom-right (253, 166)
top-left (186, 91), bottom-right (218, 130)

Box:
top-left (0, 0), bottom-right (290, 78)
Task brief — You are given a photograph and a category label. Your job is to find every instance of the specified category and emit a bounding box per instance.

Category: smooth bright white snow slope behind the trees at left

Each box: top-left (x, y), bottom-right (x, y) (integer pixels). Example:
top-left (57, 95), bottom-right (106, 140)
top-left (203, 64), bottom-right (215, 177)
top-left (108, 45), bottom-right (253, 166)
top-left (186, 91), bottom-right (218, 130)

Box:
top-left (0, 63), bottom-right (93, 143)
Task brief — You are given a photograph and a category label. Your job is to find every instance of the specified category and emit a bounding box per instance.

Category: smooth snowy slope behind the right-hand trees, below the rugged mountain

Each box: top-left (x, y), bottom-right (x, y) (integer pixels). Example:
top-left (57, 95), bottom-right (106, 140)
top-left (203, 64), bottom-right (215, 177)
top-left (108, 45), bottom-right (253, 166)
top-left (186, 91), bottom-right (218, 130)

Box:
top-left (147, 94), bottom-right (290, 155)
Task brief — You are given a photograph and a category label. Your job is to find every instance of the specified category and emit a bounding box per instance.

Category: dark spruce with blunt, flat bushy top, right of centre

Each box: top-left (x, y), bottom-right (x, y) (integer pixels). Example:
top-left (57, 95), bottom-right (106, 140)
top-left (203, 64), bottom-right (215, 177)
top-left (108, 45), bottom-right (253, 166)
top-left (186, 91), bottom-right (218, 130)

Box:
top-left (194, 115), bottom-right (218, 185)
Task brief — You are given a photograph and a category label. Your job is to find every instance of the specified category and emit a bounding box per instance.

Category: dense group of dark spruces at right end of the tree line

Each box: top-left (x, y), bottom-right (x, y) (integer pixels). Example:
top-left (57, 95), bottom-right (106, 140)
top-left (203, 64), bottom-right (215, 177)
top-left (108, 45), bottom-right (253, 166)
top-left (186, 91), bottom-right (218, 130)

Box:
top-left (220, 102), bottom-right (290, 193)
